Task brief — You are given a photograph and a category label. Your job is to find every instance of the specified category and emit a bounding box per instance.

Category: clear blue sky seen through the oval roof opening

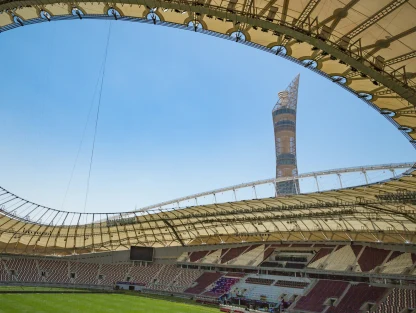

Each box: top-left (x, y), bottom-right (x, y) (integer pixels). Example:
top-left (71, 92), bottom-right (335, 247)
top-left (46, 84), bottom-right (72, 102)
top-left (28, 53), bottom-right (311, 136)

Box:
top-left (0, 20), bottom-right (415, 212)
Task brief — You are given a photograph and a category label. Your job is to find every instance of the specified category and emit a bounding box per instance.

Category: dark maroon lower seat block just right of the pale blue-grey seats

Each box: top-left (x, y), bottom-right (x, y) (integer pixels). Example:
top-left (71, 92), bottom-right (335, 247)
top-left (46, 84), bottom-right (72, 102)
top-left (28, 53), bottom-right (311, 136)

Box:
top-left (295, 280), bottom-right (349, 313)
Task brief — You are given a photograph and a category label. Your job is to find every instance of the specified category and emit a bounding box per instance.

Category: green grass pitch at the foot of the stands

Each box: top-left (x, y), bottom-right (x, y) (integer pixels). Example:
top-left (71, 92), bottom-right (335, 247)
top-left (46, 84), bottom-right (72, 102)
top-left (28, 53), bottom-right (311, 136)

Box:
top-left (0, 293), bottom-right (219, 313)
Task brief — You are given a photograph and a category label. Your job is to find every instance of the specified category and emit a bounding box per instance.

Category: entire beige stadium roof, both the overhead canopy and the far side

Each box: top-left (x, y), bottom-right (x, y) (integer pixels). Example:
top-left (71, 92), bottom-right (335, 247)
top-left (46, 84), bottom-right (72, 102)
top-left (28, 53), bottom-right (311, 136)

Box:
top-left (0, 0), bottom-right (416, 253)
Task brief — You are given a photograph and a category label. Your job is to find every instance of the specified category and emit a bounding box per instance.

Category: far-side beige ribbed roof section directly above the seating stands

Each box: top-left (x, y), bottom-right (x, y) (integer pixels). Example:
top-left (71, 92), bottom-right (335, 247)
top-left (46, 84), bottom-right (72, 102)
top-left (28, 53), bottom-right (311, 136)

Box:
top-left (0, 169), bottom-right (416, 254)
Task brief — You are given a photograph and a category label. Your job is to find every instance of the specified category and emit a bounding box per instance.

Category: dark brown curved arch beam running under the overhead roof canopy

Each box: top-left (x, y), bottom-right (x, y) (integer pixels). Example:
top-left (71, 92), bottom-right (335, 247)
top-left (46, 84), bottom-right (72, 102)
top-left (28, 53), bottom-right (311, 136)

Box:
top-left (0, 0), bottom-right (416, 105)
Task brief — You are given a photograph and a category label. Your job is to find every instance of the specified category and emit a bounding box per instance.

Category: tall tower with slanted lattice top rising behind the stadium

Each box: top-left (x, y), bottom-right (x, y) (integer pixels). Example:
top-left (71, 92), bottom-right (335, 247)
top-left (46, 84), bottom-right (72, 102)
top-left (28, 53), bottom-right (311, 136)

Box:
top-left (272, 74), bottom-right (300, 195)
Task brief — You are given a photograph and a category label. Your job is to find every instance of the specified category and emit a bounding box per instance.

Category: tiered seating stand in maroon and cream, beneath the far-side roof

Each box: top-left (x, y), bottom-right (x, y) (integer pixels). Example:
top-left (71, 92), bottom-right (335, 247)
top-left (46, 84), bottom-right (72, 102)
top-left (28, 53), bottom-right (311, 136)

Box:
top-left (0, 245), bottom-right (416, 313)
